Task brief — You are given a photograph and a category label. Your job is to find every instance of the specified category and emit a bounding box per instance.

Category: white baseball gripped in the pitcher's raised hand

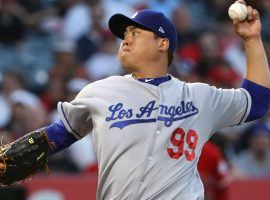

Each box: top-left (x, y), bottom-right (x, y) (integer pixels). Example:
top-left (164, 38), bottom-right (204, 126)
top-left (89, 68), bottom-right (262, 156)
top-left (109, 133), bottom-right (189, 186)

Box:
top-left (228, 2), bottom-right (247, 21)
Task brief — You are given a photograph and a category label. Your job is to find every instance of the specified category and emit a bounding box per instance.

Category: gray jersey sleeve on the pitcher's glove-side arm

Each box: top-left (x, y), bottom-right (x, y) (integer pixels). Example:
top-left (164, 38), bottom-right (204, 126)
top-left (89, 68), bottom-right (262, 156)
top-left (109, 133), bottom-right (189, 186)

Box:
top-left (57, 84), bottom-right (93, 139)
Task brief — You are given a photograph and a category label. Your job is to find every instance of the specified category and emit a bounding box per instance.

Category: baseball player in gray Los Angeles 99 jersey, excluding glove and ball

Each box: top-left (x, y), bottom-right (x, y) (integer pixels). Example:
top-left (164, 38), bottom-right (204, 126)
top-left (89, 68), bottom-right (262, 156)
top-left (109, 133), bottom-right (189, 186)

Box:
top-left (0, 0), bottom-right (270, 200)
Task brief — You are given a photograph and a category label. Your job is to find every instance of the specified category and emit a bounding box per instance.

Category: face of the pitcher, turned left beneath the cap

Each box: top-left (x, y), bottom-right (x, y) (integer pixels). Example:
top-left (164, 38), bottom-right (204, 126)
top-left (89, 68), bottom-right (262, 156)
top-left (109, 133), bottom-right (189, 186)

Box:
top-left (118, 26), bottom-right (159, 72)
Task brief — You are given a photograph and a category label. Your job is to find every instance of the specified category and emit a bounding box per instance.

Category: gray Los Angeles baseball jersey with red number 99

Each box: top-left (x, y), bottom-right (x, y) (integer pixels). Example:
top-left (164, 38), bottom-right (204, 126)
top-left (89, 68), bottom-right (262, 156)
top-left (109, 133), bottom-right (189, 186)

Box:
top-left (58, 75), bottom-right (251, 200)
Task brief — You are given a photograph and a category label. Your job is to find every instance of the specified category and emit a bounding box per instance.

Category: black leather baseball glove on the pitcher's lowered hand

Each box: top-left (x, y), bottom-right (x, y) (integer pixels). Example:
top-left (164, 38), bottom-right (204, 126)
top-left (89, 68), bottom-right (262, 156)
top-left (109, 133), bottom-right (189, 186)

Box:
top-left (0, 130), bottom-right (50, 185)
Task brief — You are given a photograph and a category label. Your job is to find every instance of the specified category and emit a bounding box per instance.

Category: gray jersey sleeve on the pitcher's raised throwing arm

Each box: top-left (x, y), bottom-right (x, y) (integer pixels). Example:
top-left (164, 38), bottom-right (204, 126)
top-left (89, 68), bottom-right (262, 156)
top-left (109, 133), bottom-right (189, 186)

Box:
top-left (210, 87), bottom-right (251, 131)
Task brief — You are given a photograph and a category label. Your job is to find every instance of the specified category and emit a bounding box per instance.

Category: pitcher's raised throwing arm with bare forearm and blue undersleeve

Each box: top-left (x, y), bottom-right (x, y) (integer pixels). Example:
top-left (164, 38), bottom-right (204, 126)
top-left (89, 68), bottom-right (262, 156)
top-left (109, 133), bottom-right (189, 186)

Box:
top-left (233, 0), bottom-right (270, 122)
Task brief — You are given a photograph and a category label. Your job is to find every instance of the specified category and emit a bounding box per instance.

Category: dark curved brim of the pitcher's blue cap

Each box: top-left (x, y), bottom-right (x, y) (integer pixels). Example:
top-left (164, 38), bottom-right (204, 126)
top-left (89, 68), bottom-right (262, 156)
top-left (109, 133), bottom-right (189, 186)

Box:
top-left (109, 14), bottom-right (152, 40)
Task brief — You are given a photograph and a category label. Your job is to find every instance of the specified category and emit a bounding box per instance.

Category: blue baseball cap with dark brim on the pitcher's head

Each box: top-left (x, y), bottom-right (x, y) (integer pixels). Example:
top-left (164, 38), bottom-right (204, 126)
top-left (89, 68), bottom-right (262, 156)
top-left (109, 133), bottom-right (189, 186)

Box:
top-left (109, 9), bottom-right (177, 52)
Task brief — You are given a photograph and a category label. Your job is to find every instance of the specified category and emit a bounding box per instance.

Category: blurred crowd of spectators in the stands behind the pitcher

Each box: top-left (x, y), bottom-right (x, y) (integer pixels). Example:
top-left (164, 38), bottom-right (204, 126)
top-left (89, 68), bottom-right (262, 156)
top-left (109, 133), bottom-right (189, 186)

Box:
top-left (0, 0), bottom-right (270, 200)
